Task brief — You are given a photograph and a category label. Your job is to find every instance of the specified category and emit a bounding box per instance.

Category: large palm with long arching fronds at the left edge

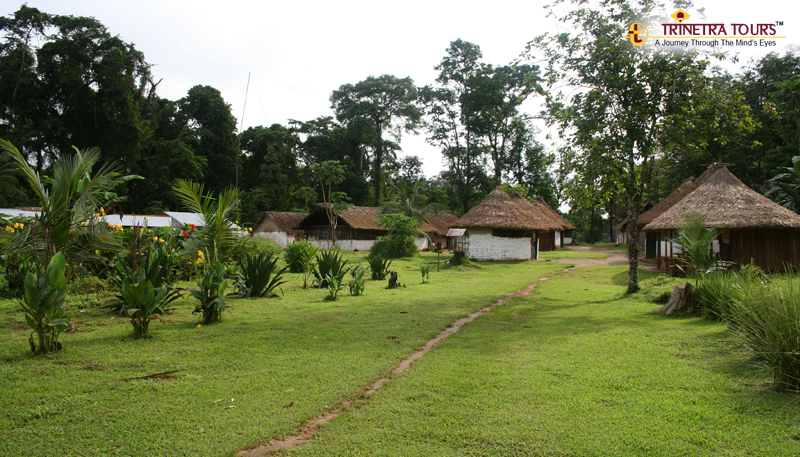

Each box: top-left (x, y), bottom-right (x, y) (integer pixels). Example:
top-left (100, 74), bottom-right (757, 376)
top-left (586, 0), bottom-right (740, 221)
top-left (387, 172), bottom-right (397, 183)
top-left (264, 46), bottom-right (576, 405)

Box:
top-left (0, 140), bottom-right (141, 268)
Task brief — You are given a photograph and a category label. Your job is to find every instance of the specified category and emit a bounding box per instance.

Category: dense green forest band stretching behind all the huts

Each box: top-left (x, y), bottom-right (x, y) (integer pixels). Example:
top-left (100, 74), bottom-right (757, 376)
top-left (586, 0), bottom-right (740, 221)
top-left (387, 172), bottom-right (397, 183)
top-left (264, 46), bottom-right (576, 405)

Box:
top-left (0, 2), bottom-right (800, 241)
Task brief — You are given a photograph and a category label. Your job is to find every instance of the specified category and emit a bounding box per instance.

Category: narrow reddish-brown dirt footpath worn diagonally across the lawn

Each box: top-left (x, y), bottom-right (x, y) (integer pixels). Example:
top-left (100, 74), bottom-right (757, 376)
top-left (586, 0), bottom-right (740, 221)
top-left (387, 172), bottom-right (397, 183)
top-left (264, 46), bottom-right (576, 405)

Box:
top-left (237, 272), bottom-right (552, 457)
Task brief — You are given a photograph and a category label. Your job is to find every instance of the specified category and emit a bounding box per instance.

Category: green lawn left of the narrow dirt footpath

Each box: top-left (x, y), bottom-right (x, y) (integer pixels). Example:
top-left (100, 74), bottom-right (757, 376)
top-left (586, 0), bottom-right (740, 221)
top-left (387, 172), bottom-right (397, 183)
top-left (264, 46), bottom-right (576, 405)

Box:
top-left (0, 253), bottom-right (564, 456)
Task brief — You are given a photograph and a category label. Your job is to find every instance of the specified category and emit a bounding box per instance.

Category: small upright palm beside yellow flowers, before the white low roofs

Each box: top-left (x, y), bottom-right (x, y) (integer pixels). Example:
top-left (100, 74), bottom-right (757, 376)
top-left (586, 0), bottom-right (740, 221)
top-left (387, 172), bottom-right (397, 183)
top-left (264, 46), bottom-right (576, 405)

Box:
top-left (172, 179), bottom-right (242, 267)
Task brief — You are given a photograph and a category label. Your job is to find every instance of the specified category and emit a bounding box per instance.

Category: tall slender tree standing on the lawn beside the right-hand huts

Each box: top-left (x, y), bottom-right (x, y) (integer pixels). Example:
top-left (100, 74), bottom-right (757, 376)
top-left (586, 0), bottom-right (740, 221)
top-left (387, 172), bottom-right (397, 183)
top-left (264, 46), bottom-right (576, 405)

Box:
top-left (529, 0), bottom-right (748, 292)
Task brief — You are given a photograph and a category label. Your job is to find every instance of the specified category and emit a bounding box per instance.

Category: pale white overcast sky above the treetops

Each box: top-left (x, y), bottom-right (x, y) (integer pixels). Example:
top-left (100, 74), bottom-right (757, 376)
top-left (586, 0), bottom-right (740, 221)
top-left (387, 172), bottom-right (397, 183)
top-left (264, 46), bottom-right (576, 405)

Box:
top-left (12, 0), bottom-right (800, 176)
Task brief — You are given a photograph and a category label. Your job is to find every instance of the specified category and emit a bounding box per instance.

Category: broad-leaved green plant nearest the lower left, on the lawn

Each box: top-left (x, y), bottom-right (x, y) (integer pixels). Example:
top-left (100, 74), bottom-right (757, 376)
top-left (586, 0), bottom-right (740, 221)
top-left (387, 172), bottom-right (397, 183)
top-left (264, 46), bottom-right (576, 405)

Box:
top-left (20, 252), bottom-right (69, 354)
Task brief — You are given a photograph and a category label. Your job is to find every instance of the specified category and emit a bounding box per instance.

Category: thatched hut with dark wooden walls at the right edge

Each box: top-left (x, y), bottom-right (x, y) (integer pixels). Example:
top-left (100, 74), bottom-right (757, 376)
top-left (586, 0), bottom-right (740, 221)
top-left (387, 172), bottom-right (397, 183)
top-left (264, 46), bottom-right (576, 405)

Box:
top-left (644, 164), bottom-right (800, 271)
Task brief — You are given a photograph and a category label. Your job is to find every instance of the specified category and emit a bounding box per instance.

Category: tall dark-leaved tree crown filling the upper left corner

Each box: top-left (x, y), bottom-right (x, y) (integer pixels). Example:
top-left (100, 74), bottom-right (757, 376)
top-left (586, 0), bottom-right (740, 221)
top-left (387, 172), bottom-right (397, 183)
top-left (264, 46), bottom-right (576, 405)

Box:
top-left (0, 5), bottom-right (155, 171)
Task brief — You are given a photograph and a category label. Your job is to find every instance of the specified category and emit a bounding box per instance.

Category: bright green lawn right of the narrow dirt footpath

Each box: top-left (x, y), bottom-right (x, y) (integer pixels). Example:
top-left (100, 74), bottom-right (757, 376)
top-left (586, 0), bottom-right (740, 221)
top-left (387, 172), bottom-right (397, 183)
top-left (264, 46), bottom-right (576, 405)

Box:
top-left (291, 266), bottom-right (800, 456)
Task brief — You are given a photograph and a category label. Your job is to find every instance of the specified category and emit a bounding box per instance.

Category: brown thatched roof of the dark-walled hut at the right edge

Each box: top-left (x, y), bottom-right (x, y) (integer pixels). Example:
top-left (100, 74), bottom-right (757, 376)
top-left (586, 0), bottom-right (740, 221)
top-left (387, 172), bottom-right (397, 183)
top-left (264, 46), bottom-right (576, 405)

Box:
top-left (644, 164), bottom-right (800, 231)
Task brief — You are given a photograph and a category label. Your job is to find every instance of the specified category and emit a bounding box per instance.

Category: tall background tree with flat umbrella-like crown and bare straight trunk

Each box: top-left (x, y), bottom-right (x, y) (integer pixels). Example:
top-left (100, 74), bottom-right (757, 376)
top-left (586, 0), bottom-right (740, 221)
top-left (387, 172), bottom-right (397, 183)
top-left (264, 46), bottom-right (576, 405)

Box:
top-left (331, 75), bottom-right (421, 206)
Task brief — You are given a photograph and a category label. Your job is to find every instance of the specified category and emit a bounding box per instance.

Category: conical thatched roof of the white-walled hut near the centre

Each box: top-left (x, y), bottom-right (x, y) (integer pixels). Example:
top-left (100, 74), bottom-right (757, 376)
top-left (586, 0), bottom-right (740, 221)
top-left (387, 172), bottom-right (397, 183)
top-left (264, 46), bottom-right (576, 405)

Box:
top-left (456, 186), bottom-right (550, 230)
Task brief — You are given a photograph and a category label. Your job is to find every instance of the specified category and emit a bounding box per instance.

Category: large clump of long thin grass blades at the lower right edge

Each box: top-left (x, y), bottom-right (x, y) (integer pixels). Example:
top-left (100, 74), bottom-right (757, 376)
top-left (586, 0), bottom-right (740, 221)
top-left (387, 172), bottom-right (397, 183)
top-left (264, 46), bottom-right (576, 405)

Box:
top-left (724, 276), bottom-right (800, 392)
